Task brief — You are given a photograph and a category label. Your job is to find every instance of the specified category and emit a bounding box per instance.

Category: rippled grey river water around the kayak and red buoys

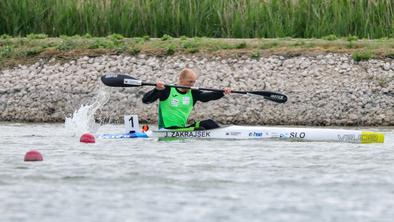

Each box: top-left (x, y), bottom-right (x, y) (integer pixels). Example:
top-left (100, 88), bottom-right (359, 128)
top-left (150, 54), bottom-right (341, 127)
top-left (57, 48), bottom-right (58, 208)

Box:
top-left (0, 123), bottom-right (394, 222)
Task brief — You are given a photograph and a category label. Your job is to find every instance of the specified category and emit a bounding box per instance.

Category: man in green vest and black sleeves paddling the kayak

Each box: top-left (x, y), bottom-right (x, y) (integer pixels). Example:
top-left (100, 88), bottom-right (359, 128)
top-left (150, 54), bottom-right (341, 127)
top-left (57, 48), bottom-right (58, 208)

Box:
top-left (142, 68), bottom-right (231, 130)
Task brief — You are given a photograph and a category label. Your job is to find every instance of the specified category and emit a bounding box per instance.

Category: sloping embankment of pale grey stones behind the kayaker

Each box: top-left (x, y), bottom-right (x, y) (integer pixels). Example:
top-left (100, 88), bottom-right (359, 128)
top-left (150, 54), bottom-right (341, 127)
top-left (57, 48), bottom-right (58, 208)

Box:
top-left (0, 54), bottom-right (394, 126)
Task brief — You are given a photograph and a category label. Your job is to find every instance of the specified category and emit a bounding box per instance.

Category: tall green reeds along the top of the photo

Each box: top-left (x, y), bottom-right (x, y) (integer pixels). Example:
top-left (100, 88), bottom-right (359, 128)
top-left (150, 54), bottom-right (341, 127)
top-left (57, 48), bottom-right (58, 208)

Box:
top-left (0, 0), bottom-right (394, 39)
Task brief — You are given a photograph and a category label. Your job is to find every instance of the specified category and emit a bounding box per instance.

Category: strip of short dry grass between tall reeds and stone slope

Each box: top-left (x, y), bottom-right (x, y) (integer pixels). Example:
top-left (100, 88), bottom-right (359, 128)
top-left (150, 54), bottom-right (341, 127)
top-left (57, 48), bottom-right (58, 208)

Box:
top-left (0, 34), bottom-right (394, 69)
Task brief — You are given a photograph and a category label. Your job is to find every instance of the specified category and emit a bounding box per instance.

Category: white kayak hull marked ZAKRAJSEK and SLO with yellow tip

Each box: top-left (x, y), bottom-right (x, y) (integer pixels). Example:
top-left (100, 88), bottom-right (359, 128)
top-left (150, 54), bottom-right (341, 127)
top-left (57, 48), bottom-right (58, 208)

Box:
top-left (150, 126), bottom-right (384, 143)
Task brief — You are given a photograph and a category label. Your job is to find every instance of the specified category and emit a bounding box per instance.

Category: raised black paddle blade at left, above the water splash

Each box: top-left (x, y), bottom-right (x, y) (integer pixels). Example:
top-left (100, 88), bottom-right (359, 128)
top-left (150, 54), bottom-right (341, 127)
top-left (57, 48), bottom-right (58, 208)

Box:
top-left (101, 73), bottom-right (142, 87)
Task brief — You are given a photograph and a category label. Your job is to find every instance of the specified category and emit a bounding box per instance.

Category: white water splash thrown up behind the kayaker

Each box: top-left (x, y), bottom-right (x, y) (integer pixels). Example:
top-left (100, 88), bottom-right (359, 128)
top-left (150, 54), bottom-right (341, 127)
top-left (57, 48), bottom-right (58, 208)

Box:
top-left (64, 90), bottom-right (109, 136)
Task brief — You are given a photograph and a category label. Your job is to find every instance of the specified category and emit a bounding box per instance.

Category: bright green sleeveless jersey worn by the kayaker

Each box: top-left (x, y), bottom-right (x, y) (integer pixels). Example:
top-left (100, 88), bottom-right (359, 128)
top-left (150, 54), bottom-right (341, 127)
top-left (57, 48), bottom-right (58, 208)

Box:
top-left (158, 87), bottom-right (193, 128)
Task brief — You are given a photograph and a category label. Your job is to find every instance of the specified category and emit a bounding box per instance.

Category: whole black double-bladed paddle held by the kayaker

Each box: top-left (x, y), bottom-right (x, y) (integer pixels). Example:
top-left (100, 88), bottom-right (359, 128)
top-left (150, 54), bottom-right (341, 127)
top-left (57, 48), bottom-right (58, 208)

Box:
top-left (101, 73), bottom-right (287, 103)
